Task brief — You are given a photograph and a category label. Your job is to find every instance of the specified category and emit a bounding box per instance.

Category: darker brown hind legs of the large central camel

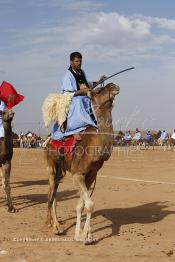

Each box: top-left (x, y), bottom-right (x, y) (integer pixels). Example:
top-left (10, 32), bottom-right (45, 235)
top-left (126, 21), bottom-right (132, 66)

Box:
top-left (46, 167), bottom-right (63, 234)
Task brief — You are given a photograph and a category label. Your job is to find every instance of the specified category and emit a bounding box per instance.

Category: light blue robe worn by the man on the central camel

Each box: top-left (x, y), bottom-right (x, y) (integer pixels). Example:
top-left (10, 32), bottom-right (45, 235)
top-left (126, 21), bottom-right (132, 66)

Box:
top-left (51, 70), bottom-right (97, 140)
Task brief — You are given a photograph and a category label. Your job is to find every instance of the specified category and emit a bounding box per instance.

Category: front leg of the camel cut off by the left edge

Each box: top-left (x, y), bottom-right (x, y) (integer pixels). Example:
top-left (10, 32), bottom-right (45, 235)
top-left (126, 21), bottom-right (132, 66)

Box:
top-left (3, 161), bottom-right (17, 212)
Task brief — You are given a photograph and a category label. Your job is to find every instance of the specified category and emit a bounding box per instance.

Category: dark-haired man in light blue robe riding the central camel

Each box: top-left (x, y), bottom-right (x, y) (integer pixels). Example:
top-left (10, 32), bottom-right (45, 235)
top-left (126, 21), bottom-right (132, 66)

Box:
top-left (52, 52), bottom-right (106, 140)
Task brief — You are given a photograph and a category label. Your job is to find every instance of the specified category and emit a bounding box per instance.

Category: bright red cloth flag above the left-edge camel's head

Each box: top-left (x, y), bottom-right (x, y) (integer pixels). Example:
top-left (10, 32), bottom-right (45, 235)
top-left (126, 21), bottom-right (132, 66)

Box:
top-left (0, 81), bottom-right (24, 109)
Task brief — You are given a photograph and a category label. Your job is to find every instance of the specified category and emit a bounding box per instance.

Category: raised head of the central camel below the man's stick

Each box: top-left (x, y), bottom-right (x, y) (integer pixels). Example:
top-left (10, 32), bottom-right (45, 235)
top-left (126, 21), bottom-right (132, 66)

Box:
top-left (92, 83), bottom-right (120, 109)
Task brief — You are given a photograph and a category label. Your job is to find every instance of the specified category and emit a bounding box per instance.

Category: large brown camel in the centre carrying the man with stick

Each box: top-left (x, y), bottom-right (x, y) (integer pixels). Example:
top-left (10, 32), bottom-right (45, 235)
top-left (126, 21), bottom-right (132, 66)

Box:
top-left (44, 83), bottom-right (119, 244)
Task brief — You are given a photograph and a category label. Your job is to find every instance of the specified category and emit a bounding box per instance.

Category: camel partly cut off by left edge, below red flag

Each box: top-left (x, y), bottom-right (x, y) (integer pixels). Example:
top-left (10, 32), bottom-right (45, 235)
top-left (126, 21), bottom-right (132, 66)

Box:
top-left (0, 109), bottom-right (17, 212)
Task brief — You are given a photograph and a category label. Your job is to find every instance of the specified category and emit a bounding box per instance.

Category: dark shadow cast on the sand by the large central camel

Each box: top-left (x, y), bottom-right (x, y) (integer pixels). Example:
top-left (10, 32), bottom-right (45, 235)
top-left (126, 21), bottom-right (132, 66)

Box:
top-left (64, 202), bottom-right (175, 242)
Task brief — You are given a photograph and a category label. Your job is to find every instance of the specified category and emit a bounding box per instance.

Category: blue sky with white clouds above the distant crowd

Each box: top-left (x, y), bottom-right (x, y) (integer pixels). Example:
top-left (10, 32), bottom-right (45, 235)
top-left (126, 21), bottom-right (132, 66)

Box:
top-left (0, 0), bottom-right (175, 132)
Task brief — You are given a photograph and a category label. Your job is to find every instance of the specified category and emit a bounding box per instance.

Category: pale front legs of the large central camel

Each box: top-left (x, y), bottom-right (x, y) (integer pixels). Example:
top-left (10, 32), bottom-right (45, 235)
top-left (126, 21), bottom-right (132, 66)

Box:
top-left (73, 174), bottom-right (94, 244)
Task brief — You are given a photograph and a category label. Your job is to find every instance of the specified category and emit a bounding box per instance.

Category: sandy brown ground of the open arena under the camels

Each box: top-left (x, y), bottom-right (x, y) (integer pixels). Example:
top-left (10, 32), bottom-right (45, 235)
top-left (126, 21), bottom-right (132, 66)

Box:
top-left (0, 148), bottom-right (175, 262)
